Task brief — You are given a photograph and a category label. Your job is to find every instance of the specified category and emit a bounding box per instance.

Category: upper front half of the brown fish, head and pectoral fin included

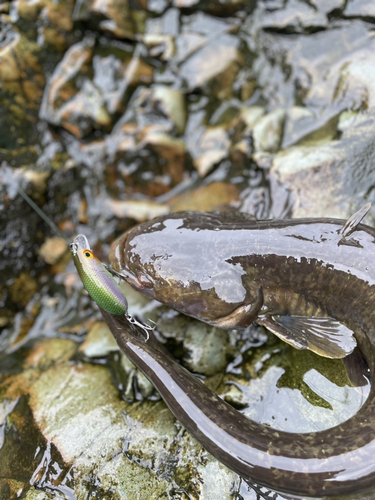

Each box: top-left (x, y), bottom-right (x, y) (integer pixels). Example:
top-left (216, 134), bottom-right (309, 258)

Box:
top-left (110, 207), bottom-right (375, 358)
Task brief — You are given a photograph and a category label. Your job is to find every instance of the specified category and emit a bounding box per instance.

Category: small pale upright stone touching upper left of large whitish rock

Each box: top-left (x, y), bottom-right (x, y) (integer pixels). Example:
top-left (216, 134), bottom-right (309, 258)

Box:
top-left (253, 109), bottom-right (286, 153)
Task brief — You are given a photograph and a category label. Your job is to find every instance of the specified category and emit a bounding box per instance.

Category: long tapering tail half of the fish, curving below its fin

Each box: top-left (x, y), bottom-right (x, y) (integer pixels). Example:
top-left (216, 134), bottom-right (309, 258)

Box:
top-left (102, 311), bottom-right (375, 500)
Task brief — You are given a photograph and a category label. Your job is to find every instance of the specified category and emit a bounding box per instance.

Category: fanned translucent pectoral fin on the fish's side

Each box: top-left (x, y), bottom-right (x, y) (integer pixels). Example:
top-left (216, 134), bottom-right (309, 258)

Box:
top-left (257, 316), bottom-right (357, 358)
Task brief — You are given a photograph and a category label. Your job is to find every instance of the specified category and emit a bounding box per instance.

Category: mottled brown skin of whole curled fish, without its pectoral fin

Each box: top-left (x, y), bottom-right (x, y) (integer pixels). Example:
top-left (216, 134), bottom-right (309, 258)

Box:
top-left (106, 212), bottom-right (375, 499)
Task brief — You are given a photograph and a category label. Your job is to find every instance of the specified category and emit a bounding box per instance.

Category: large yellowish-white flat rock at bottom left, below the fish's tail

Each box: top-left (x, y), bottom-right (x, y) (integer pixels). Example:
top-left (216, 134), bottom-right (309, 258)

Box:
top-left (0, 339), bottom-right (209, 500)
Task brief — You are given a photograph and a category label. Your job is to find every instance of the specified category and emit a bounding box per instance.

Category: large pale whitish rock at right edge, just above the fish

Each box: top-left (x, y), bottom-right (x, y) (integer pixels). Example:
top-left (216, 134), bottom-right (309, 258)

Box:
top-left (271, 115), bottom-right (375, 218)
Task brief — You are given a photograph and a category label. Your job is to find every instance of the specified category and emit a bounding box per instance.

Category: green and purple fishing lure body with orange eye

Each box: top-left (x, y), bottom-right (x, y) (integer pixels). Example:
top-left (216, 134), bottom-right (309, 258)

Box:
top-left (70, 234), bottom-right (128, 316)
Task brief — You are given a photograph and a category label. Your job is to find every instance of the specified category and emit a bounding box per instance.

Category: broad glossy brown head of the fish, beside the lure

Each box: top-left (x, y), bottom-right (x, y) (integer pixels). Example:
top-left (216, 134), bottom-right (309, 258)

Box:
top-left (109, 212), bottom-right (246, 321)
